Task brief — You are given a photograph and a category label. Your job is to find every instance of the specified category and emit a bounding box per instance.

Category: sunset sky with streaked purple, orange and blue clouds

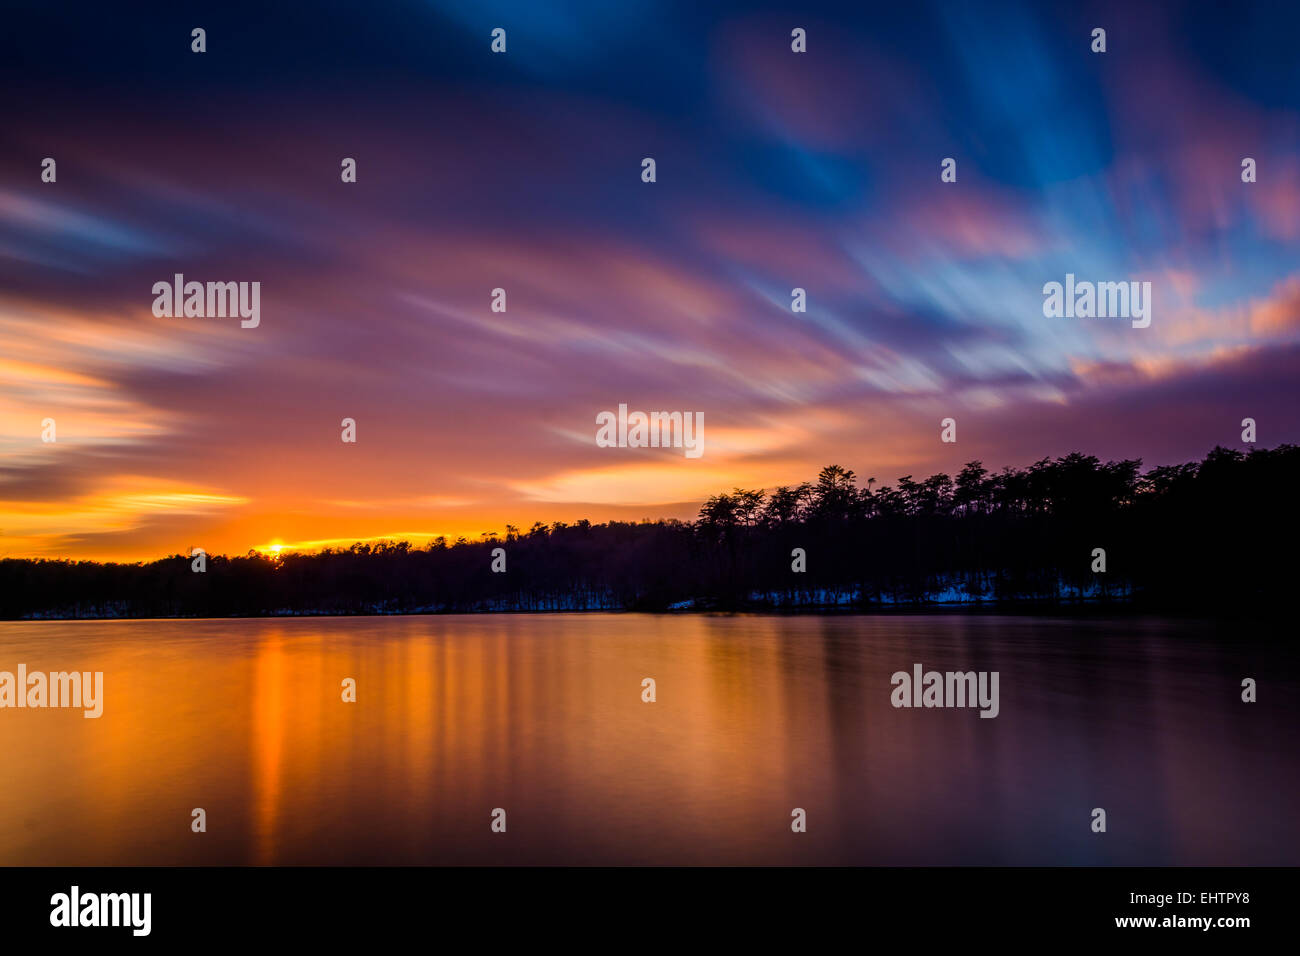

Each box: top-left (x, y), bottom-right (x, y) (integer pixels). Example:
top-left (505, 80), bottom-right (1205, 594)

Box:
top-left (0, 0), bottom-right (1300, 561)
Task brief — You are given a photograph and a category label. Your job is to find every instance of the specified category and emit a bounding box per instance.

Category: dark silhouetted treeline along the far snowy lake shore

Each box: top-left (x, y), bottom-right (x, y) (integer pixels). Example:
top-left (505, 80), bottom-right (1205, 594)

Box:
top-left (0, 445), bottom-right (1300, 618)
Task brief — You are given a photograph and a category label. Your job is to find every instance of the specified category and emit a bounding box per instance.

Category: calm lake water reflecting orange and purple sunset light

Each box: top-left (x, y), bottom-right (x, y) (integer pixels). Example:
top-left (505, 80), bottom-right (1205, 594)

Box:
top-left (0, 614), bottom-right (1300, 865)
